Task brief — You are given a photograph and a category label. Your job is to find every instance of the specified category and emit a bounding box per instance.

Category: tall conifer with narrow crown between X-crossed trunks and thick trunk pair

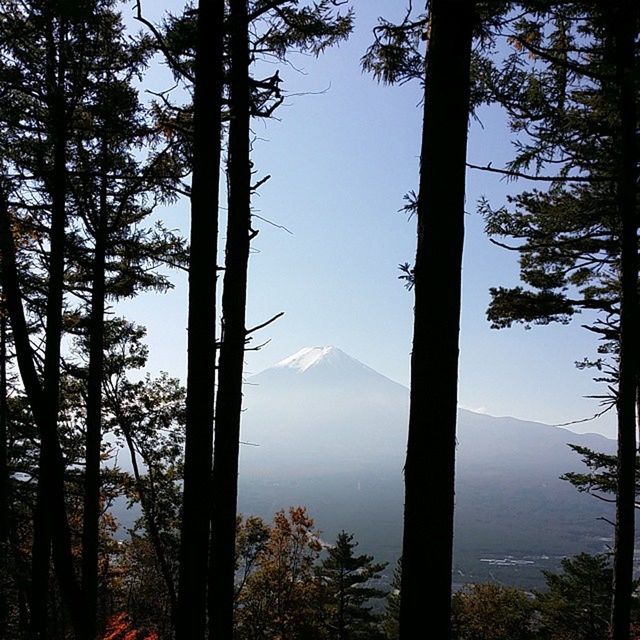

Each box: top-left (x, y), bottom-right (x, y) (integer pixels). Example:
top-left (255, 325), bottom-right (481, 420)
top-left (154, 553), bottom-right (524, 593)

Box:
top-left (67, 17), bottom-right (183, 637)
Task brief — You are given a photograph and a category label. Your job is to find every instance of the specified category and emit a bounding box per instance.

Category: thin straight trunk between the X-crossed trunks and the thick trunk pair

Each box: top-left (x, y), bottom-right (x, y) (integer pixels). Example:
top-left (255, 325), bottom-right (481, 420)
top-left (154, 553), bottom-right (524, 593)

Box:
top-left (82, 175), bottom-right (108, 640)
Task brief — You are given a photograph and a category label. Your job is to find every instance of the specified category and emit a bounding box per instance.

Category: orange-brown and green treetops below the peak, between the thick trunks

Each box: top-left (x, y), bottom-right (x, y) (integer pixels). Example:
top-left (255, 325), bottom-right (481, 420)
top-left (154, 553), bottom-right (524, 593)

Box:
top-left (236, 507), bottom-right (386, 640)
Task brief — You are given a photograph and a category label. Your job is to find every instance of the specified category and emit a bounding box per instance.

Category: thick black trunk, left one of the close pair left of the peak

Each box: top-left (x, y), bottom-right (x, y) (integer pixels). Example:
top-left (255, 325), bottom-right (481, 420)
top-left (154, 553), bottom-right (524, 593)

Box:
top-left (176, 0), bottom-right (224, 640)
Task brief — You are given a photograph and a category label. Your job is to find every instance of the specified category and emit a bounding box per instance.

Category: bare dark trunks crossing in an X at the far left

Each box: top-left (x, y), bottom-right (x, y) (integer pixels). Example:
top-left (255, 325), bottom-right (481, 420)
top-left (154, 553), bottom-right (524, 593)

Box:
top-left (0, 17), bottom-right (84, 640)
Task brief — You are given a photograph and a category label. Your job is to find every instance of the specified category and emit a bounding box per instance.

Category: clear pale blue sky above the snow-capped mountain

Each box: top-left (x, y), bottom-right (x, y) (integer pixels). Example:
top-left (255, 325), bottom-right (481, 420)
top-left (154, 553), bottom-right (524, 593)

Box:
top-left (123, 0), bottom-right (615, 436)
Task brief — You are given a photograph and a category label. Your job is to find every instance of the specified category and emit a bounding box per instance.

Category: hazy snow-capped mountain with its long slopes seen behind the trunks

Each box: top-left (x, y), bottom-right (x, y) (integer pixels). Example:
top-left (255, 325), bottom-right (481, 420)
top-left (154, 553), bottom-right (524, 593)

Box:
top-left (240, 347), bottom-right (615, 586)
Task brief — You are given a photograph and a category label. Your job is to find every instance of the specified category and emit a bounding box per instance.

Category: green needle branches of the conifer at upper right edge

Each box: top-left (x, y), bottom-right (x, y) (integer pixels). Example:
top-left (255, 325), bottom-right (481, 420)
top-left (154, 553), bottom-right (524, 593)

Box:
top-left (478, 2), bottom-right (636, 404)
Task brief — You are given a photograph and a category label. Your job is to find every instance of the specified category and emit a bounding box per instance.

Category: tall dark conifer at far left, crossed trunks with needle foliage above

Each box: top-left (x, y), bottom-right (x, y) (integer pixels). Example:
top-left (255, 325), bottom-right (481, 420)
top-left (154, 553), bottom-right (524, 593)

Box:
top-left (0, 1), bottom-right (104, 638)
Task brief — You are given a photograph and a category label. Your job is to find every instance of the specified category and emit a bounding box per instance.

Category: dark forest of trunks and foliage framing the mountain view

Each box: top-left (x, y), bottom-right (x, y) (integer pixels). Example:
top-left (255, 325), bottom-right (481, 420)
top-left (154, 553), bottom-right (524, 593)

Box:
top-left (0, 0), bottom-right (640, 640)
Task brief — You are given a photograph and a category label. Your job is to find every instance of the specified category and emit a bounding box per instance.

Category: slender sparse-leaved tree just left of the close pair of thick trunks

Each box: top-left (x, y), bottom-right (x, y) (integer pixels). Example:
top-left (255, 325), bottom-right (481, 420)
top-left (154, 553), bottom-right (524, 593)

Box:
top-left (105, 322), bottom-right (185, 633)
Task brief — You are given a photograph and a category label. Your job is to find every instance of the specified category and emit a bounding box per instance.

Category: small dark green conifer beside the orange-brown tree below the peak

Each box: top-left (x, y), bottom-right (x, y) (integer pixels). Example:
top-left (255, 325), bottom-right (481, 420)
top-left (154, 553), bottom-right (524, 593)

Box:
top-left (318, 531), bottom-right (386, 640)
